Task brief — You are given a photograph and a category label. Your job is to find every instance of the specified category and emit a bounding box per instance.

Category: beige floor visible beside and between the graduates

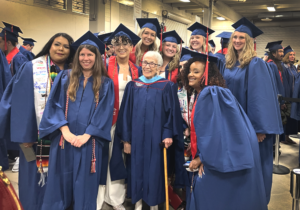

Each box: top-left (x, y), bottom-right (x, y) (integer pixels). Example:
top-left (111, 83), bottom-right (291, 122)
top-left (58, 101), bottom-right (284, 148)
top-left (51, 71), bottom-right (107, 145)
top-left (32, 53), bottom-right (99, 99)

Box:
top-left (5, 137), bottom-right (299, 210)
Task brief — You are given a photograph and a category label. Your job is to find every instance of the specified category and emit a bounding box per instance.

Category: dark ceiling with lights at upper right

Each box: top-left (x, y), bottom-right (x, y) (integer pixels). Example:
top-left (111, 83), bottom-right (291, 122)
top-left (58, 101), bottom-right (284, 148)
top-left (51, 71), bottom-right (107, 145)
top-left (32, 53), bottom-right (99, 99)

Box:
top-left (163, 0), bottom-right (300, 22)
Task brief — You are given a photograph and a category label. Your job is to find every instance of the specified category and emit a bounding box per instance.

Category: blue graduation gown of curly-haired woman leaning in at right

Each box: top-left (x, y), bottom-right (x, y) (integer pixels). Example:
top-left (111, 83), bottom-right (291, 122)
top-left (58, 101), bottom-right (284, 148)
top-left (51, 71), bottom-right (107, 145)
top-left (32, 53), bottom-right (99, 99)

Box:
top-left (194, 86), bottom-right (267, 210)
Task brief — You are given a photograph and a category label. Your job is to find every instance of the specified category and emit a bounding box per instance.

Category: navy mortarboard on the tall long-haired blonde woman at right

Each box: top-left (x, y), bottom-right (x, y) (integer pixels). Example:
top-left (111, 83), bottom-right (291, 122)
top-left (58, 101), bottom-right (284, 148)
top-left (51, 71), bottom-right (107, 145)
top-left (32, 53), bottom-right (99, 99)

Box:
top-left (232, 17), bottom-right (263, 38)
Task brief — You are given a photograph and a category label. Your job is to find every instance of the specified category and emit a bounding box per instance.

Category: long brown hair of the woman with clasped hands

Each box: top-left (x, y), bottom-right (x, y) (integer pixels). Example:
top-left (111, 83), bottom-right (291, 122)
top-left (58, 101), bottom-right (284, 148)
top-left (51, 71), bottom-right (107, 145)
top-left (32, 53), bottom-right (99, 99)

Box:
top-left (68, 45), bottom-right (107, 102)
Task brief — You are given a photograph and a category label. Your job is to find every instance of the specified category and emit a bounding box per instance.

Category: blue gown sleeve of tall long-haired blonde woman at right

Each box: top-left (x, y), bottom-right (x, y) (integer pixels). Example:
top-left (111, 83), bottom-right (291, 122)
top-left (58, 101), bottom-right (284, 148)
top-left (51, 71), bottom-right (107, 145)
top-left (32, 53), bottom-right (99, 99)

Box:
top-left (245, 58), bottom-right (283, 134)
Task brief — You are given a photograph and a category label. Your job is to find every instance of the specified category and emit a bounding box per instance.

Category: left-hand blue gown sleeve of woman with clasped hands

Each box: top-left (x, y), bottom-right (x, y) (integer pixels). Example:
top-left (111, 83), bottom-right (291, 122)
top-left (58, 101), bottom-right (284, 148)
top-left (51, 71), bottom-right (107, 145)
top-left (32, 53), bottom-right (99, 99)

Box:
top-left (39, 70), bottom-right (70, 140)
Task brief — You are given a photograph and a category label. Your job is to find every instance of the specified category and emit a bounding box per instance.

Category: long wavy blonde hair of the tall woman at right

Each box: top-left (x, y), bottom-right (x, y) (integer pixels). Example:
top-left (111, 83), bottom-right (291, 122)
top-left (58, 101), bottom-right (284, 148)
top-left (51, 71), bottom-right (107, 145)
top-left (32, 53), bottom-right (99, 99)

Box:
top-left (225, 33), bottom-right (257, 69)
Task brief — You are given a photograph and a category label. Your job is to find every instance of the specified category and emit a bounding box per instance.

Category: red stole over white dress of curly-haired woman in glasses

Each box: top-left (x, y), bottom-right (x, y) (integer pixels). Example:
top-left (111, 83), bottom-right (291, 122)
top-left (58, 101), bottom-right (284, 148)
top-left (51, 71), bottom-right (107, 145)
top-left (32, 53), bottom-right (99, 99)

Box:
top-left (107, 56), bottom-right (139, 125)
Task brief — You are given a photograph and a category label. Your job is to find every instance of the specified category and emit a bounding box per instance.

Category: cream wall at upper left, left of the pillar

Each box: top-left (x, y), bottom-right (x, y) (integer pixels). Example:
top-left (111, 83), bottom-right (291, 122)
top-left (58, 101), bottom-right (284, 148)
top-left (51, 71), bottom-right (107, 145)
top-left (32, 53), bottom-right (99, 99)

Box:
top-left (0, 0), bottom-right (89, 54)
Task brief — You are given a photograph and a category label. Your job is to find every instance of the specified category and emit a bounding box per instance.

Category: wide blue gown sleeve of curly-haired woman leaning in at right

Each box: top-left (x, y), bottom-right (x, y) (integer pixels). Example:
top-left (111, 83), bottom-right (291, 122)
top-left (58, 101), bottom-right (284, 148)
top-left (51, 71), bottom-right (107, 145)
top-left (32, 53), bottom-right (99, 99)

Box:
top-left (194, 86), bottom-right (257, 173)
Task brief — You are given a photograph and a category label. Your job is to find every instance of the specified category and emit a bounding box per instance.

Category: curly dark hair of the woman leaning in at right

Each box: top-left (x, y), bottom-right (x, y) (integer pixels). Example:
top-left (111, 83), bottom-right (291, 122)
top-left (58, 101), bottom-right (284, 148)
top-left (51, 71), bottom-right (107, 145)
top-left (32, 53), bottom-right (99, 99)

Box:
top-left (180, 57), bottom-right (226, 93)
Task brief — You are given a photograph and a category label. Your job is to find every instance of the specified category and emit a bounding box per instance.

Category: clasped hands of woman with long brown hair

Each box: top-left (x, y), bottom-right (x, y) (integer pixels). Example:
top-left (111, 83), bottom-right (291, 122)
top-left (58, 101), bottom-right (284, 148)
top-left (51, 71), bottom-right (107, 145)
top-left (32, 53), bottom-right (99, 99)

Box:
top-left (60, 126), bottom-right (91, 148)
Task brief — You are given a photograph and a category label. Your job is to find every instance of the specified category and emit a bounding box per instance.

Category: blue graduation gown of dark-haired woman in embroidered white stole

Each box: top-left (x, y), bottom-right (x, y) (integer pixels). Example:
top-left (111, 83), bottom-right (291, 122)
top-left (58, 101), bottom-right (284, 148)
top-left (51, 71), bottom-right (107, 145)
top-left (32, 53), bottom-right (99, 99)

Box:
top-left (0, 58), bottom-right (66, 210)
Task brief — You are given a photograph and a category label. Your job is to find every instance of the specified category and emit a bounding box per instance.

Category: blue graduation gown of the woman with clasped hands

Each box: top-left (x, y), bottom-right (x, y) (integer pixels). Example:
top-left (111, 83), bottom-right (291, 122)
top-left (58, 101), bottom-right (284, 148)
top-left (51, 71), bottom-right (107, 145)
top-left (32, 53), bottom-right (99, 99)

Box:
top-left (39, 71), bottom-right (114, 210)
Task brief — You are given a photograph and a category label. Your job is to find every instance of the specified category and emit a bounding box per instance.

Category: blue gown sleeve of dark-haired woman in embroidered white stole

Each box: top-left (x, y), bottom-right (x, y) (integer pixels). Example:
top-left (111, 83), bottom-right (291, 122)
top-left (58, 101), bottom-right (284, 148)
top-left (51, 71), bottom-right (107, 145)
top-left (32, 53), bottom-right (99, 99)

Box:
top-left (10, 62), bottom-right (38, 143)
